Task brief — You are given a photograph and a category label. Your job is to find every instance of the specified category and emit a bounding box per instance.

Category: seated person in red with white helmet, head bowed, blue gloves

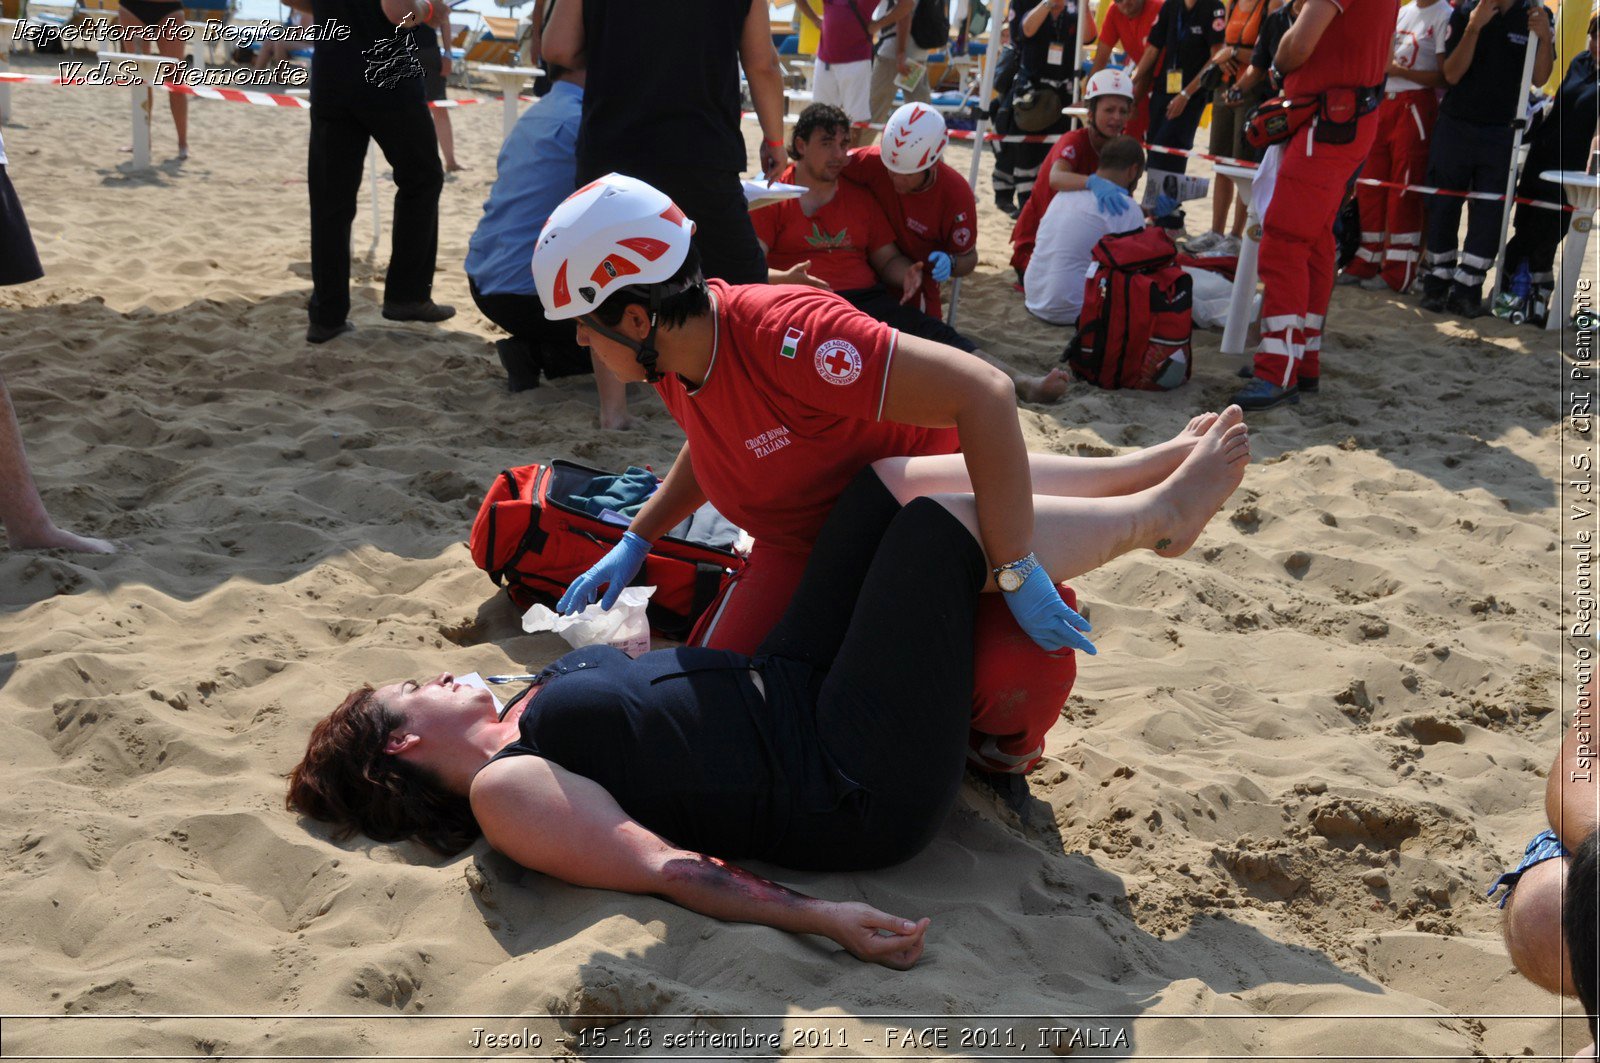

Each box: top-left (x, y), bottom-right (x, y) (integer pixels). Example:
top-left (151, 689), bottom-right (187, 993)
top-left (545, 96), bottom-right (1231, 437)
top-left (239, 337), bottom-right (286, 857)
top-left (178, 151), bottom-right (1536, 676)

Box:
top-left (843, 104), bottom-right (978, 317)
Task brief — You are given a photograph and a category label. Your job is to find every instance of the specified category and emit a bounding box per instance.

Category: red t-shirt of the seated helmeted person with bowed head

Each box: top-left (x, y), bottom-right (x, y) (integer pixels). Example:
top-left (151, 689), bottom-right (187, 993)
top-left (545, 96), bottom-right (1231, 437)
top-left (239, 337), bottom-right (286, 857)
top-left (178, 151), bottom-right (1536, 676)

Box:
top-left (845, 147), bottom-right (978, 317)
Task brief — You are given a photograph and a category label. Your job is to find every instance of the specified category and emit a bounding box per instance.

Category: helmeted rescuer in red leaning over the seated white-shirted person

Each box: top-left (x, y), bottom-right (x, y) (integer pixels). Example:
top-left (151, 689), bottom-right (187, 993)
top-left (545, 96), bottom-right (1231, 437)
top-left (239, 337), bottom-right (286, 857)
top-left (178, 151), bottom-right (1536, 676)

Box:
top-left (1011, 66), bottom-right (1150, 280)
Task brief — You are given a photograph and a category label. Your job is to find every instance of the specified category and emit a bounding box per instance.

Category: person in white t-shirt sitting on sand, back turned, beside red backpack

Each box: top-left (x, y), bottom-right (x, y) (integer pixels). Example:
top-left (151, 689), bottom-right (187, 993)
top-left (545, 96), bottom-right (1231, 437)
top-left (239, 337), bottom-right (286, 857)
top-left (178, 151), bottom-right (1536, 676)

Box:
top-left (1022, 136), bottom-right (1144, 325)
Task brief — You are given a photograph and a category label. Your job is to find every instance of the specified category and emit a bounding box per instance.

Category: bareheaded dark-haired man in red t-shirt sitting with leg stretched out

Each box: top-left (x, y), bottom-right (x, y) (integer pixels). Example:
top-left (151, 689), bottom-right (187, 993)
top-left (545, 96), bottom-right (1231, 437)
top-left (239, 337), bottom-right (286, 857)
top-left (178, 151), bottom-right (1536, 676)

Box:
top-left (750, 104), bottom-right (1069, 402)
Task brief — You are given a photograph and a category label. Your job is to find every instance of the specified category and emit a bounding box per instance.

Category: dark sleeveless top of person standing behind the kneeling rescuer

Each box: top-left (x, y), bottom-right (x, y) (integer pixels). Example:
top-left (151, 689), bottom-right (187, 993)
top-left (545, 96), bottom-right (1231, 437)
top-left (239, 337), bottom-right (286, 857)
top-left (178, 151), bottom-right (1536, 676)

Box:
top-left (578, 0), bottom-right (750, 176)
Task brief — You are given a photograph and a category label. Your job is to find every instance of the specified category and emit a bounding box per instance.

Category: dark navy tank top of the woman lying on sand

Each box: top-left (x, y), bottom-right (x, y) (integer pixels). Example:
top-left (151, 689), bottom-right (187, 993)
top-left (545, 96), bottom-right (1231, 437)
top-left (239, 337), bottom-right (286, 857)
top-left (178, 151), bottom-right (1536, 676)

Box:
top-left (491, 647), bottom-right (853, 856)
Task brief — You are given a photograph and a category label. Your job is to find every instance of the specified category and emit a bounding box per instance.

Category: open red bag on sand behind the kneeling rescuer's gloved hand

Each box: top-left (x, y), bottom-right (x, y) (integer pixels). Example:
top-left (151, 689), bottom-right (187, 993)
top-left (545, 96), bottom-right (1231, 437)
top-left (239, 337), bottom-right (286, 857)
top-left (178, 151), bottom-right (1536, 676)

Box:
top-left (469, 461), bottom-right (744, 639)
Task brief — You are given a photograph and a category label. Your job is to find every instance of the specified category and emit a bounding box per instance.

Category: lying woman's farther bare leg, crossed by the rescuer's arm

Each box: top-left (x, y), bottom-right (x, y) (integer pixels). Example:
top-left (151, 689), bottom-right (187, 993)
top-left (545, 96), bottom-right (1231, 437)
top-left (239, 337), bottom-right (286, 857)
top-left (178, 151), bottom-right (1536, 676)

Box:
top-left (872, 413), bottom-right (1218, 504)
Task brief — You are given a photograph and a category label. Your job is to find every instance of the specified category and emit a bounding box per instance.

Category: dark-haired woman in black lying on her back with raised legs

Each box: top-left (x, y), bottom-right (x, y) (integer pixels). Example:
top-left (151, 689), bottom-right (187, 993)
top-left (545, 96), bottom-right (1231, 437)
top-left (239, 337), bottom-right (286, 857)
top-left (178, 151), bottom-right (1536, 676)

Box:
top-left (288, 407), bottom-right (1250, 969)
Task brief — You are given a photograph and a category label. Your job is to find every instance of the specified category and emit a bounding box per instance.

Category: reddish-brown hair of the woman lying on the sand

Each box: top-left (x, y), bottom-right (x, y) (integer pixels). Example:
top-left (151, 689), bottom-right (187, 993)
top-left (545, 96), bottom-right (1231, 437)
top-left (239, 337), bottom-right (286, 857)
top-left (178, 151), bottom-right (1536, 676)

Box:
top-left (283, 685), bottom-right (480, 856)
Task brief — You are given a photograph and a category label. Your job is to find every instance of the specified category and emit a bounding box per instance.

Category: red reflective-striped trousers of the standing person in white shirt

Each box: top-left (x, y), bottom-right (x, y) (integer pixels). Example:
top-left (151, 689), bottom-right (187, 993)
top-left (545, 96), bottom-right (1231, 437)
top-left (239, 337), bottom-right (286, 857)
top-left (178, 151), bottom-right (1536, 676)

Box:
top-left (1344, 88), bottom-right (1438, 291)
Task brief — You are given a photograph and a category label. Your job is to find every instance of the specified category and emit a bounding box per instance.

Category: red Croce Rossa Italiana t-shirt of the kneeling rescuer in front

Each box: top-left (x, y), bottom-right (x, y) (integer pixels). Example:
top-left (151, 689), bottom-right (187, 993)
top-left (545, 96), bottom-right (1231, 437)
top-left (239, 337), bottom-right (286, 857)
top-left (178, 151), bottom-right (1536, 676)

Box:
top-left (656, 278), bottom-right (960, 551)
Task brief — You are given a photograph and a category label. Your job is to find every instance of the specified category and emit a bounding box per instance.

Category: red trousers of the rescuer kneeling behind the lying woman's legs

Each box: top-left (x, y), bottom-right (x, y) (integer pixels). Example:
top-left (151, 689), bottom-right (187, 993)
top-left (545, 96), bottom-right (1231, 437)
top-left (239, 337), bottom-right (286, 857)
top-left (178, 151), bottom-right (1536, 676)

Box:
top-left (690, 543), bottom-right (1078, 773)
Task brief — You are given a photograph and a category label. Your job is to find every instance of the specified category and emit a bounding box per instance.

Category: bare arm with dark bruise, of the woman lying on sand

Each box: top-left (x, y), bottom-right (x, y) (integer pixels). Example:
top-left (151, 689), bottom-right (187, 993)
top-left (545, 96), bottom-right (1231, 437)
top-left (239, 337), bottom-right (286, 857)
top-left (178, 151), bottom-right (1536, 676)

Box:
top-left (472, 757), bottom-right (928, 970)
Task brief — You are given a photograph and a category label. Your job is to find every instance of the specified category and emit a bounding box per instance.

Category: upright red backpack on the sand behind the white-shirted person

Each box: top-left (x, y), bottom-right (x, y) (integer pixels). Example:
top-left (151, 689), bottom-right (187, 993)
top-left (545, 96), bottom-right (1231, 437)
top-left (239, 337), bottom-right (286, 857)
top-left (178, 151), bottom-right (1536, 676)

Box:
top-left (1061, 226), bottom-right (1194, 391)
